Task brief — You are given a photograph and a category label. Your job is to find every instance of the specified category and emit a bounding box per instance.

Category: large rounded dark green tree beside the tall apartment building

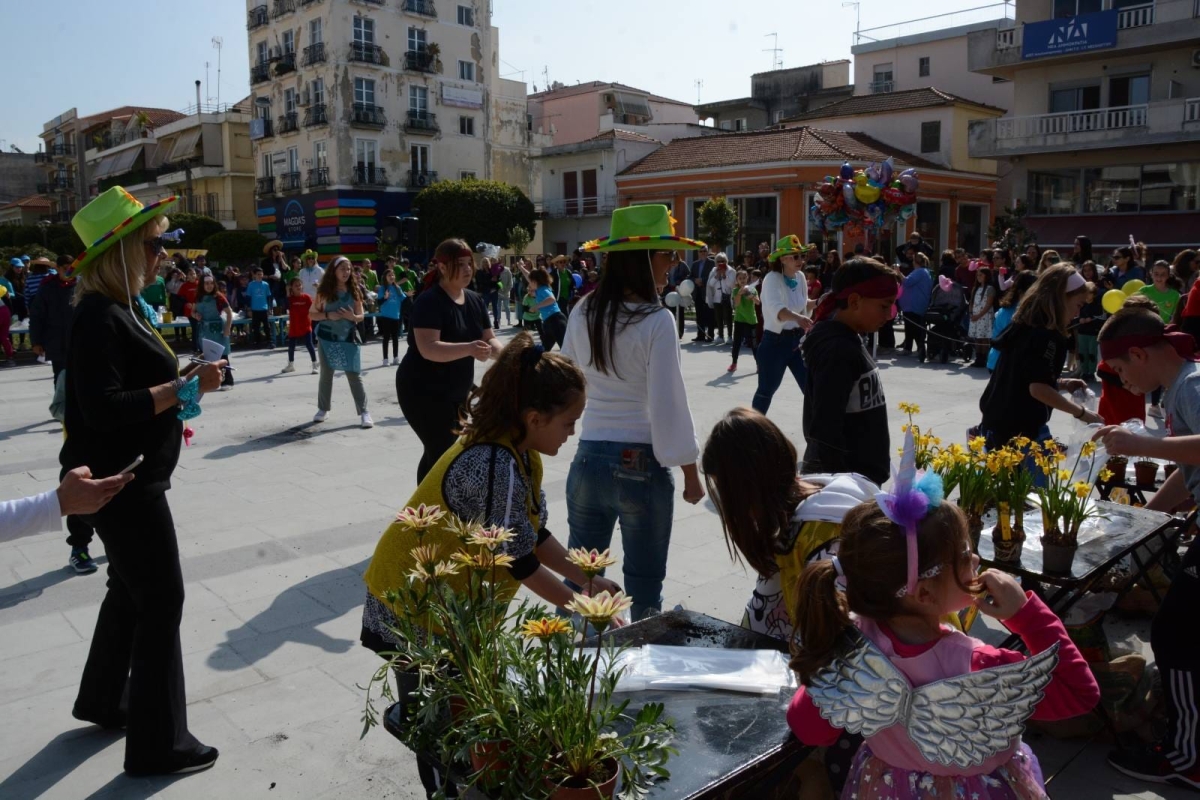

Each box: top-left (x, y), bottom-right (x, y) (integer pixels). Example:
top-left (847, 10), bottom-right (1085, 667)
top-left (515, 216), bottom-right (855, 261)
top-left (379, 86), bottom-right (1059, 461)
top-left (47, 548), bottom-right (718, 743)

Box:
top-left (413, 180), bottom-right (535, 255)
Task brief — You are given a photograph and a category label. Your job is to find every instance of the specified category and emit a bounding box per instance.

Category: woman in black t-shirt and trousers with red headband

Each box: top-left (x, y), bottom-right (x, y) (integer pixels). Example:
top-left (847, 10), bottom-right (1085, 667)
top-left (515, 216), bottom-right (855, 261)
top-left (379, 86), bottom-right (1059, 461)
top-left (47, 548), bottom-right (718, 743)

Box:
top-left (396, 239), bottom-right (502, 482)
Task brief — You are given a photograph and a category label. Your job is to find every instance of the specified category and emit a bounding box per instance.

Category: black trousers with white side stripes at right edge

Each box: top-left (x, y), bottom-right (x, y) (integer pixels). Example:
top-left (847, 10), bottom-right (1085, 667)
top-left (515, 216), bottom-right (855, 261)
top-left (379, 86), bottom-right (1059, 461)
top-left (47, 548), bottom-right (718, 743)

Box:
top-left (1150, 540), bottom-right (1200, 772)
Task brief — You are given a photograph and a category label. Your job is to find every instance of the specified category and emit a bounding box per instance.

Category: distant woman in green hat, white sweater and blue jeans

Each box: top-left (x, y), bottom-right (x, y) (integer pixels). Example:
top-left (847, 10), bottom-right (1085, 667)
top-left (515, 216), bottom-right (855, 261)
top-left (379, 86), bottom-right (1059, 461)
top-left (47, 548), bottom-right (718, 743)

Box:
top-left (751, 234), bottom-right (812, 414)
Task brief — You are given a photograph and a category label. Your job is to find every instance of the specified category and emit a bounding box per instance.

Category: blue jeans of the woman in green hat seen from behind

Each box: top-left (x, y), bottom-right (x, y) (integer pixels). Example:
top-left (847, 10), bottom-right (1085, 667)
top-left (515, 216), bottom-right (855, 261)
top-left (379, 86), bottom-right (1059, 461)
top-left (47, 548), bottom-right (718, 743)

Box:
top-left (566, 441), bottom-right (674, 621)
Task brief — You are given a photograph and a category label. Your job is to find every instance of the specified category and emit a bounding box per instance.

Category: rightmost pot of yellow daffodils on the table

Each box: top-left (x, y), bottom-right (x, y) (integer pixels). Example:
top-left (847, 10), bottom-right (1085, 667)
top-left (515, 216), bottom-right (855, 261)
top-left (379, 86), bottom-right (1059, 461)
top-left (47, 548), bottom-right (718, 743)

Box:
top-left (1033, 440), bottom-right (1111, 573)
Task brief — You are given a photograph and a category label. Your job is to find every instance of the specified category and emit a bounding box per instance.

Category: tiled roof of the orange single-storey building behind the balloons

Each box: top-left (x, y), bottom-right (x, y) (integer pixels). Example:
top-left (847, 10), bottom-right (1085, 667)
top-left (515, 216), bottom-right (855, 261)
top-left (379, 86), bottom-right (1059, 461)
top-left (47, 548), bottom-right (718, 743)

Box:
top-left (620, 127), bottom-right (944, 175)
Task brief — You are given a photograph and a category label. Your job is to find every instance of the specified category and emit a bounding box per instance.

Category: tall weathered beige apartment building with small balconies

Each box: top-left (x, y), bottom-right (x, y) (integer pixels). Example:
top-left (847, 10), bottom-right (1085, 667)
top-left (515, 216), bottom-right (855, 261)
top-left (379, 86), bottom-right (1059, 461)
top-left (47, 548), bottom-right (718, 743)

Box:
top-left (247, 0), bottom-right (535, 254)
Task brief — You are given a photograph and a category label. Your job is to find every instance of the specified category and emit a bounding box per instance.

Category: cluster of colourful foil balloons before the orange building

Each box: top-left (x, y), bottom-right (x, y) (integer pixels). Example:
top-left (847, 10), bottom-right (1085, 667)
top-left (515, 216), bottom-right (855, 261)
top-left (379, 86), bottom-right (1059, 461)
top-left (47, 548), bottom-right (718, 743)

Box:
top-left (809, 158), bottom-right (919, 236)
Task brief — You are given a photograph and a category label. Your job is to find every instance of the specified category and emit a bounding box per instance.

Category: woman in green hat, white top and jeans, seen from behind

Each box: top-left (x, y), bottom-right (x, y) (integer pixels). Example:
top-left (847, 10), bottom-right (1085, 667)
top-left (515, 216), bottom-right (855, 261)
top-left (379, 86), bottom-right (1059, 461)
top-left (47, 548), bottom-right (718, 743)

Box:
top-left (563, 205), bottom-right (704, 620)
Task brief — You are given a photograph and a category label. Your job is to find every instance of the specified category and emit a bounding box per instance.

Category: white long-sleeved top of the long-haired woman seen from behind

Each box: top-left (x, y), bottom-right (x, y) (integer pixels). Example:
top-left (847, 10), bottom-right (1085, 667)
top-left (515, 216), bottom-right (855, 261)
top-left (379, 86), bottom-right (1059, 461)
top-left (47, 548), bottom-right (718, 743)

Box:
top-left (563, 295), bottom-right (700, 467)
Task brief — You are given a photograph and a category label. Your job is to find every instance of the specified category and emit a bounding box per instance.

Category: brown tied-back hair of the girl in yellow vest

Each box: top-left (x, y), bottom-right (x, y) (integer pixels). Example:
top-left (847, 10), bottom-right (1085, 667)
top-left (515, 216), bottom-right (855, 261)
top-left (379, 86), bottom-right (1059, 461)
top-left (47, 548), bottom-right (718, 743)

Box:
top-left (457, 332), bottom-right (587, 445)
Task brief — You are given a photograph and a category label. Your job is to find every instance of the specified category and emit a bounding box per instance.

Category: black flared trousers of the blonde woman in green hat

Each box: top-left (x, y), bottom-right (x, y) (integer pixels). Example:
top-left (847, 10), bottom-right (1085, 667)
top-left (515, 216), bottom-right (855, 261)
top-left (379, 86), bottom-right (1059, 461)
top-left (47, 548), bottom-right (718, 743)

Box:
top-left (74, 485), bottom-right (199, 769)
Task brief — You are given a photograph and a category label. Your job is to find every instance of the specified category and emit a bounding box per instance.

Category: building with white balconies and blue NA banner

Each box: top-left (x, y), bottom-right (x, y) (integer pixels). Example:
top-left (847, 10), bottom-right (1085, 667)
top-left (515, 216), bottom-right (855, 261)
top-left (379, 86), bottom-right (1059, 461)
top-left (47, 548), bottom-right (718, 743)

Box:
top-left (968, 0), bottom-right (1200, 250)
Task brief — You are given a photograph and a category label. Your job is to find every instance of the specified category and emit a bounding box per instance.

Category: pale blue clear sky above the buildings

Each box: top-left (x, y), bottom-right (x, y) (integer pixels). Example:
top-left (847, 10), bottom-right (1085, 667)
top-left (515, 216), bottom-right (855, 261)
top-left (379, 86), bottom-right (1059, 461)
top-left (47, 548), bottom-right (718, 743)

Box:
top-left (0, 0), bottom-right (988, 152)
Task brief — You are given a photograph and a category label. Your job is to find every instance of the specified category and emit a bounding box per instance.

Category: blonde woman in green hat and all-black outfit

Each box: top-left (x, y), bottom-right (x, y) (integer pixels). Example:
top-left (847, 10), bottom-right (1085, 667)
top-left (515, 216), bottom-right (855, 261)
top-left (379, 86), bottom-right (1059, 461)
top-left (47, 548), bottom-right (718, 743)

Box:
top-left (59, 186), bottom-right (226, 775)
